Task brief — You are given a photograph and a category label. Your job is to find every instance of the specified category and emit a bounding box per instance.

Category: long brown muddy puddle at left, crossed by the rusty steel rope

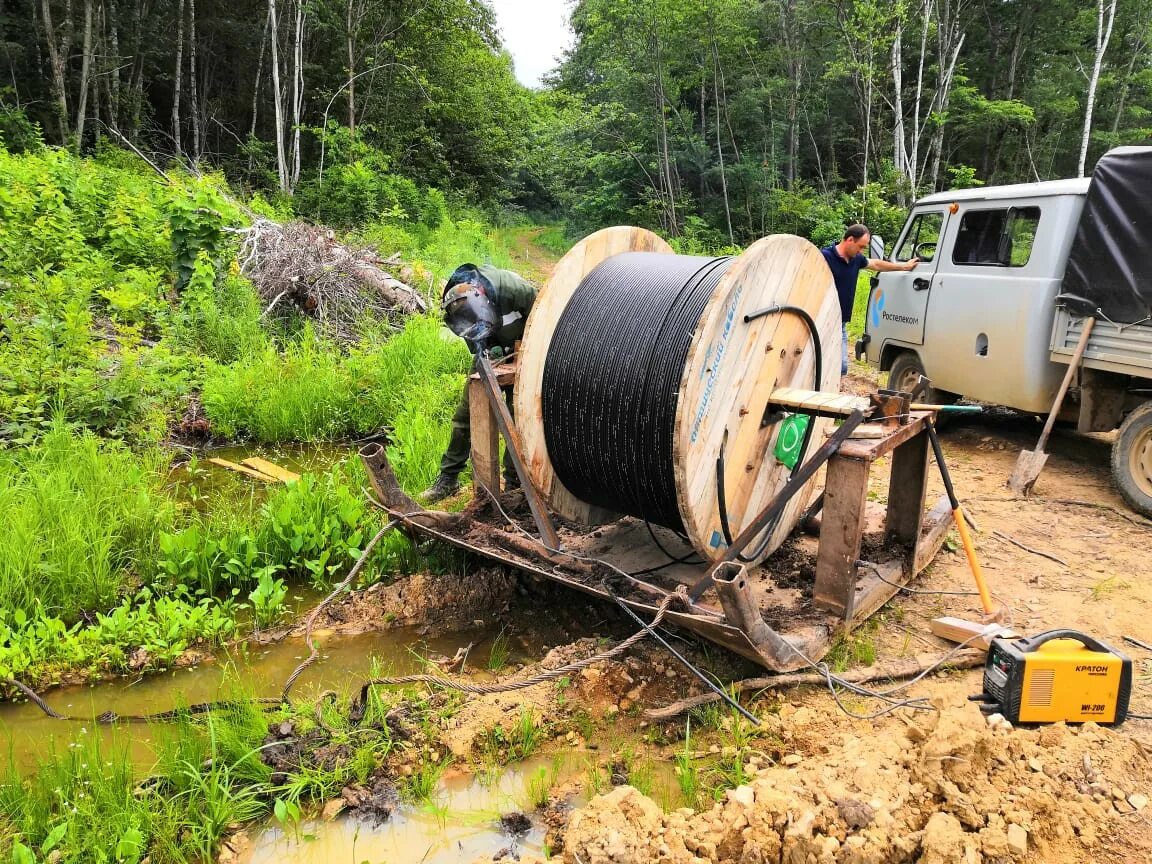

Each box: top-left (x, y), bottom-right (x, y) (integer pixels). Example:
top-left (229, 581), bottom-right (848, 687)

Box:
top-left (0, 628), bottom-right (499, 773)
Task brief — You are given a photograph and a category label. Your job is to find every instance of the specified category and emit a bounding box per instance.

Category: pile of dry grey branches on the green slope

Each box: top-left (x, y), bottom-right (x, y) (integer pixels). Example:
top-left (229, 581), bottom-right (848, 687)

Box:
top-left (240, 219), bottom-right (427, 341)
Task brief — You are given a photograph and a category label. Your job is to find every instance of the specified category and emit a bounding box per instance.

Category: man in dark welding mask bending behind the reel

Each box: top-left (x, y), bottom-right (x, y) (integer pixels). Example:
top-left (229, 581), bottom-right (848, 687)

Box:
top-left (420, 264), bottom-right (537, 503)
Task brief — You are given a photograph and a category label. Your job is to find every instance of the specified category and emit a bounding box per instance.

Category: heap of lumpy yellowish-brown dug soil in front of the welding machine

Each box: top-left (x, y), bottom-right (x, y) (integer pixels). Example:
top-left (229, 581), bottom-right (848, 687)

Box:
top-left (499, 710), bottom-right (1152, 864)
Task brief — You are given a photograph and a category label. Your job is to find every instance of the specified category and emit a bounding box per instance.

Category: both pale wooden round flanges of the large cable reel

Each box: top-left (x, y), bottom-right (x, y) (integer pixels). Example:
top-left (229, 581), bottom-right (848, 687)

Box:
top-left (515, 227), bottom-right (841, 560)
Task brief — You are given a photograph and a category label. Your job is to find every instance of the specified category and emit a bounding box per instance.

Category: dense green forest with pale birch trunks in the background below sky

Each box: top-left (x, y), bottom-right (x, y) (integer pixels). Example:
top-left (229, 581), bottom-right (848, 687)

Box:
top-left (0, 0), bottom-right (1152, 247)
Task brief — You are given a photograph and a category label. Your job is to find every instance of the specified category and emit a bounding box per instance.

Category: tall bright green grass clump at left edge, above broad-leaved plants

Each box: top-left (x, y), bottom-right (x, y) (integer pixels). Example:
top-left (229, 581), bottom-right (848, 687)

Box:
top-left (0, 425), bottom-right (174, 619)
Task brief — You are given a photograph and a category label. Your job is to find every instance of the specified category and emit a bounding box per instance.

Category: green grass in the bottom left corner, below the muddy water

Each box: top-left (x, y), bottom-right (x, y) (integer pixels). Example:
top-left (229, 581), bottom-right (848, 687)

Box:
top-left (0, 700), bottom-right (274, 864)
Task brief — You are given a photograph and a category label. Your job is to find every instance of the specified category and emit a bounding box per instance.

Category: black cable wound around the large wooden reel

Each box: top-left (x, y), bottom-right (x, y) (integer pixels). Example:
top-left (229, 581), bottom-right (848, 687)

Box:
top-left (541, 252), bottom-right (732, 532)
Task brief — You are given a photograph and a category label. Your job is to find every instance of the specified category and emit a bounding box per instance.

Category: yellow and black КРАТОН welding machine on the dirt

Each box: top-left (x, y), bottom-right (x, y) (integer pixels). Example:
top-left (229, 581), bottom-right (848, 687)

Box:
top-left (972, 630), bottom-right (1132, 726)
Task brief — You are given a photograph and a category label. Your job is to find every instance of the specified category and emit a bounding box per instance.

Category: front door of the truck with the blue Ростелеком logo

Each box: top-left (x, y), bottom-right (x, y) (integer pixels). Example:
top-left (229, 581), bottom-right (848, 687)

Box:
top-left (865, 206), bottom-right (948, 345)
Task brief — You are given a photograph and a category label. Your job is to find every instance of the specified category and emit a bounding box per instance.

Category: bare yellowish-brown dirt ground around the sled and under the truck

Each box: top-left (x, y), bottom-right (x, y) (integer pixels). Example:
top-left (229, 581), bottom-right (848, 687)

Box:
top-left (301, 368), bottom-right (1152, 864)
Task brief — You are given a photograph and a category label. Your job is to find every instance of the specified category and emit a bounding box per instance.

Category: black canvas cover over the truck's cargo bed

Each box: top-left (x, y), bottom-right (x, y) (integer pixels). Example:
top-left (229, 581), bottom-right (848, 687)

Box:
top-left (1060, 147), bottom-right (1152, 324)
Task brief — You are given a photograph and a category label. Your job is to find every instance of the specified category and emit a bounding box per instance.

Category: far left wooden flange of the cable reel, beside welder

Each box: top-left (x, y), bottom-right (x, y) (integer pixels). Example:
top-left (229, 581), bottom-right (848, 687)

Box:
top-left (515, 226), bottom-right (673, 525)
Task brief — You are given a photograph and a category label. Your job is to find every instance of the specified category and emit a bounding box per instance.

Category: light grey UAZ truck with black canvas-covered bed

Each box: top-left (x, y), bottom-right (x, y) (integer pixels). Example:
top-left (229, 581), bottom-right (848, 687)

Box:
top-left (856, 147), bottom-right (1152, 515)
